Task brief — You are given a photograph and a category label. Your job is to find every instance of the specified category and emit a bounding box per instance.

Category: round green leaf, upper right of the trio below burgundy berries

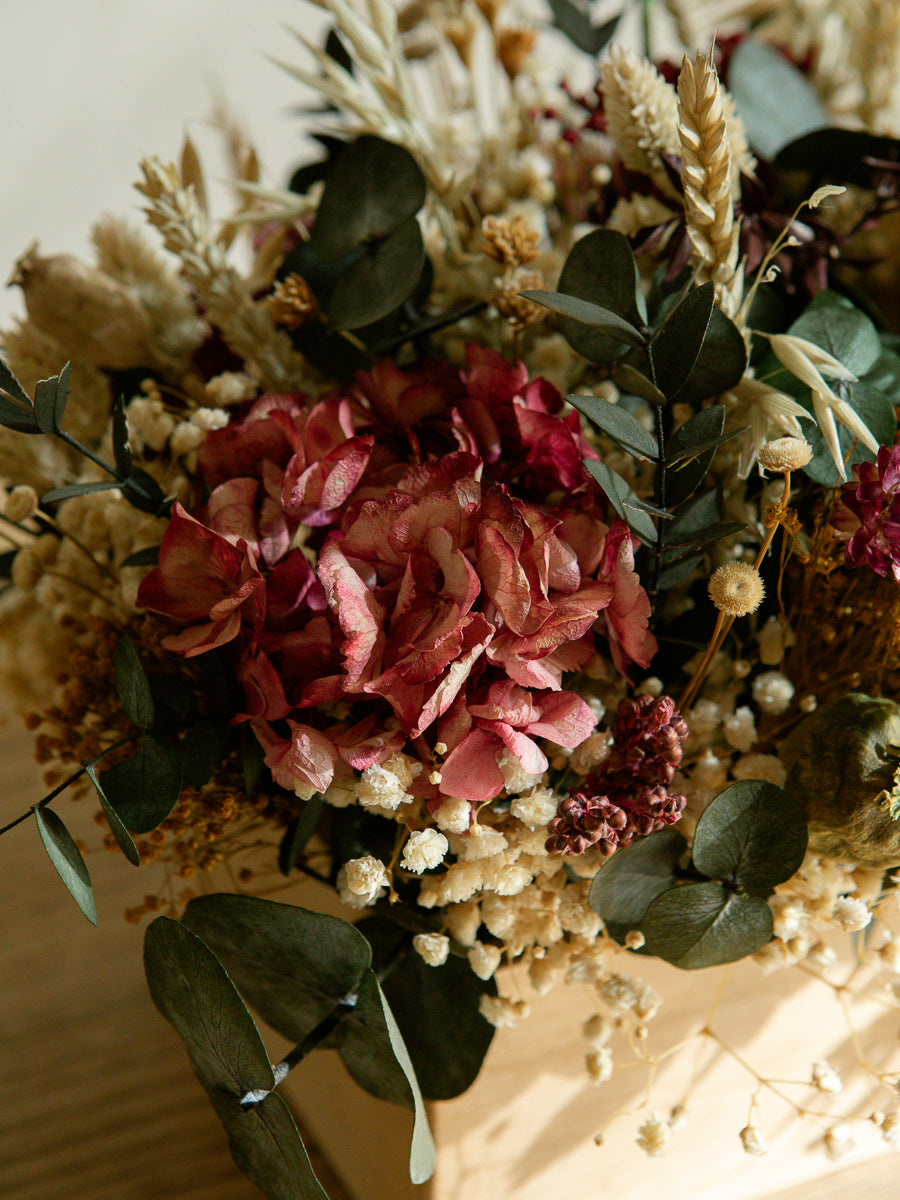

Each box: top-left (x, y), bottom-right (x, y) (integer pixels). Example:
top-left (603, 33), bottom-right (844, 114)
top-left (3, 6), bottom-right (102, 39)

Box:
top-left (691, 779), bottom-right (808, 896)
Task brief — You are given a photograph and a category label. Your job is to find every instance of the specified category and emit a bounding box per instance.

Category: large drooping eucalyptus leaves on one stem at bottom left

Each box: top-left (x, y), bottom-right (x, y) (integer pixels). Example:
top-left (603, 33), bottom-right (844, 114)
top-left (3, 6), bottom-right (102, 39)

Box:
top-left (145, 895), bottom-right (434, 1200)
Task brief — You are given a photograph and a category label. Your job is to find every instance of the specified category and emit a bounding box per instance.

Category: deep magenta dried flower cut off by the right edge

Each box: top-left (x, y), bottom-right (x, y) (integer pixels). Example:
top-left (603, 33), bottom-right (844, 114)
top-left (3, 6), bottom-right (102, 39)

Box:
top-left (832, 445), bottom-right (900, 582)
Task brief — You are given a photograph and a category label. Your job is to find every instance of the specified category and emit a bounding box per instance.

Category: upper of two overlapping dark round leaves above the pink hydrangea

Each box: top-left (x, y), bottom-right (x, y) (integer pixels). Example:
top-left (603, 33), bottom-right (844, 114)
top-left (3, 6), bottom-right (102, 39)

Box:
top-left (312, 134), bottom-right (426, 261)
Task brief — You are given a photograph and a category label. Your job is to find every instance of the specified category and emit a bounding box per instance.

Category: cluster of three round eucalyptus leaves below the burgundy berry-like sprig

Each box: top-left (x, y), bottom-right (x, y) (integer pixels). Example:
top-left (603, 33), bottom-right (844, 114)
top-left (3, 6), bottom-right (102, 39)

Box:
top-left (590, 780), bottom-right (806, 970)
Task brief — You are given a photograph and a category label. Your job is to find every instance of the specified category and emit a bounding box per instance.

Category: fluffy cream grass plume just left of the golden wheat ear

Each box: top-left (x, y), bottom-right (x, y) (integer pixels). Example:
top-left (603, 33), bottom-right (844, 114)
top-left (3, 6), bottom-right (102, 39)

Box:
top-left (600, 44), bottom-right (680, 196)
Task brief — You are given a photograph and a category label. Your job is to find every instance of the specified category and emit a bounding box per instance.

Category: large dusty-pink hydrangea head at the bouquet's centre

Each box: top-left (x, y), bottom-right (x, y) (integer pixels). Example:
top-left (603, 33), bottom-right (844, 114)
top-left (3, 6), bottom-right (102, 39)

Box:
top-left (139, 347), bottom-right (655, 805)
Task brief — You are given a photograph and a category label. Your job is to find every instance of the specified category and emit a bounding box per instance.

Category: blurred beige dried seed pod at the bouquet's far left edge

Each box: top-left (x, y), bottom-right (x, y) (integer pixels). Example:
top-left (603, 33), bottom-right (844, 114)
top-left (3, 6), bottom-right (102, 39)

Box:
top-left (6, 241), bottom-right (158, 370)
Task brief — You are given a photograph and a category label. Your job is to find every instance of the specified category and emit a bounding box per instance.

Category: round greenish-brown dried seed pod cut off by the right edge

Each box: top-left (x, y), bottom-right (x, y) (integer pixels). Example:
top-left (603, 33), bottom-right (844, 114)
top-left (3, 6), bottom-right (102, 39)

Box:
top-left (780, 692), bottom-right (900, 866)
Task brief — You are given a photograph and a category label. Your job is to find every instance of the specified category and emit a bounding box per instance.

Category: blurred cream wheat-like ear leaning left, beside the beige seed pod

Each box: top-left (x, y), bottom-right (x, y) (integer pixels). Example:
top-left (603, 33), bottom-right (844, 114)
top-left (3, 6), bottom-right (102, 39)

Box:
top-left (136, 157), bottom-right (310, 391)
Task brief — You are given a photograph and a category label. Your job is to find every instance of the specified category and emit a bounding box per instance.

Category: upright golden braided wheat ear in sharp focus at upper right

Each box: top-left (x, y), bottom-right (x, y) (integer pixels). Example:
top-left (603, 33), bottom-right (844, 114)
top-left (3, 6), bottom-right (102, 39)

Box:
top-left (677, 52), bottom-right (740, 317)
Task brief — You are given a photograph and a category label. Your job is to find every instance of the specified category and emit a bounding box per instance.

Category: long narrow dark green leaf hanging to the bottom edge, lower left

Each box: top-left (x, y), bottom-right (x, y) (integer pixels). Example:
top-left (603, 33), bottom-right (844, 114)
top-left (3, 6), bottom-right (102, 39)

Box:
top-left (144, 917), bottom-right (328, 1200)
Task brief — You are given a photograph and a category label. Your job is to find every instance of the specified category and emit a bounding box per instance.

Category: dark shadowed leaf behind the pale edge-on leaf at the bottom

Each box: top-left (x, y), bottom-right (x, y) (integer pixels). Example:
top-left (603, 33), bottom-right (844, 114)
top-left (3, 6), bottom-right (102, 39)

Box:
top-left (356, 917), bottom-right (497, 1100)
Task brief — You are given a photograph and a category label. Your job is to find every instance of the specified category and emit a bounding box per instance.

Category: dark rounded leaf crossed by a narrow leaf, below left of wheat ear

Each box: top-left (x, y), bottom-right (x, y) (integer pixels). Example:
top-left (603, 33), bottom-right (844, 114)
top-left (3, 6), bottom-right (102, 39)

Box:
top-left (557, 229), bottom-right (647, 362)
